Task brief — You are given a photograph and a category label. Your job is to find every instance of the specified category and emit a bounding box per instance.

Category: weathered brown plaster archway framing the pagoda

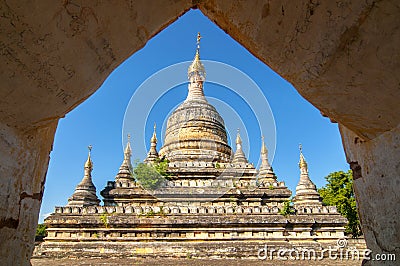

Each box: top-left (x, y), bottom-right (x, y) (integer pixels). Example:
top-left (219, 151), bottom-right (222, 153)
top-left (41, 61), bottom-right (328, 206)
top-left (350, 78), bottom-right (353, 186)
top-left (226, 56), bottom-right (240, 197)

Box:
top-left (0, 0), bottom-right (400, 264)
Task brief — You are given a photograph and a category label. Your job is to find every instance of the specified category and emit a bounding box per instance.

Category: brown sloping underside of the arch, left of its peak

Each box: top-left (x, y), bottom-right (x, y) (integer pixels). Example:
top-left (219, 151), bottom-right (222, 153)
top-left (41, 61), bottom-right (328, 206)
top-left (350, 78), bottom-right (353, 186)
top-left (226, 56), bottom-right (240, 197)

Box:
top-left (0, 1), bottom-right (194, 129)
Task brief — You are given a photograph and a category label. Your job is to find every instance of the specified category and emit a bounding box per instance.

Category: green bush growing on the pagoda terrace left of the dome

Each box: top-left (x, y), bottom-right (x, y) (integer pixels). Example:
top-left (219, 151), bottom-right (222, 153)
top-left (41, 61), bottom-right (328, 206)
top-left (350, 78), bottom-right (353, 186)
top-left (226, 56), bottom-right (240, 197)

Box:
top-left (133, 158), bottom-right (169, 190)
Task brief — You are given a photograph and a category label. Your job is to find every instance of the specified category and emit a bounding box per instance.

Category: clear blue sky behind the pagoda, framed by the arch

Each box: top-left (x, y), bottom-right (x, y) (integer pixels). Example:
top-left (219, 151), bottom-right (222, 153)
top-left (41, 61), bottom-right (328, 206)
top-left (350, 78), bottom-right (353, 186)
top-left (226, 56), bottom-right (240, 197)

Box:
top-left (39, 10), bottom-right (349, 222)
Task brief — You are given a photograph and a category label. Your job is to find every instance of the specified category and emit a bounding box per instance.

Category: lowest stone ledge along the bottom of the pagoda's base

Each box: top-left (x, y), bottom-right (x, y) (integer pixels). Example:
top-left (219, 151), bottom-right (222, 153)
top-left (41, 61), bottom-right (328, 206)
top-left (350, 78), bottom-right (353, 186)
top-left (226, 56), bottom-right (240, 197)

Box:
top-left (34, 239), bottom-right (365, 263)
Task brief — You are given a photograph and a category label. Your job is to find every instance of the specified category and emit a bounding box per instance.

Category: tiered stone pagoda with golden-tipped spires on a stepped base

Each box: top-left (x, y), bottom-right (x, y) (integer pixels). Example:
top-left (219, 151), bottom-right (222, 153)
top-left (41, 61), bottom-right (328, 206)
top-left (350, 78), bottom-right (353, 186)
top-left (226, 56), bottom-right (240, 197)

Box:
top-left (38, 35), bottom-right (347, 257)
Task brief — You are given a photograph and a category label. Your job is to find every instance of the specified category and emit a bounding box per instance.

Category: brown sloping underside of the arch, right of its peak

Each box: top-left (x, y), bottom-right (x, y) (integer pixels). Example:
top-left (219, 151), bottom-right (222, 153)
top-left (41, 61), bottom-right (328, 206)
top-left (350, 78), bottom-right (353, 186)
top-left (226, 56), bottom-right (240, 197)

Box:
top-left (199, 0), bottom-right (400, 139)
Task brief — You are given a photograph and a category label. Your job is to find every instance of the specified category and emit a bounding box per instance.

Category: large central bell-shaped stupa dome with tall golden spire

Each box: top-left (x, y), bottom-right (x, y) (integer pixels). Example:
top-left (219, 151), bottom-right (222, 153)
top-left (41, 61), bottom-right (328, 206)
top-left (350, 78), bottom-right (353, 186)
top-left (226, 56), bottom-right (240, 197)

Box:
top-left (160, 34), bottom-right (232, 163)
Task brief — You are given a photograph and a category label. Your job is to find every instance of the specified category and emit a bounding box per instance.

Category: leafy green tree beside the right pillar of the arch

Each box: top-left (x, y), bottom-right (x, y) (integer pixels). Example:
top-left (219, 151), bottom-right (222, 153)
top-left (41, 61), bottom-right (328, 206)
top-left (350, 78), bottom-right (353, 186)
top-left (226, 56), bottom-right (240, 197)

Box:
top-left (318, 170), bottom-right (362, 237)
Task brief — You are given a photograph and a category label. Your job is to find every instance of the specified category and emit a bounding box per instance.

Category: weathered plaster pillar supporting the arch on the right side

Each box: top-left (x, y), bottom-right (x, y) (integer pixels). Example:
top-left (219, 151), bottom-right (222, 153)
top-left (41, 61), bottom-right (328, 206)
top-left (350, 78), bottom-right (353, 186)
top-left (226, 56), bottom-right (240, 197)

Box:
top-left (340, 123), bottom-right (400, 265)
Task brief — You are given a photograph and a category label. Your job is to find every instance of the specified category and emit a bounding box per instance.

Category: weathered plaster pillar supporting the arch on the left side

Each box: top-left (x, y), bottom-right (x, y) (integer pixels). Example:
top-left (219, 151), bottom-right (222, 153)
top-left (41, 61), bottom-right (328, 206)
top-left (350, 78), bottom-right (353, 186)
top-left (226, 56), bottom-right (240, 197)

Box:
top-left (0, 123), bottom-right (57, 265)
